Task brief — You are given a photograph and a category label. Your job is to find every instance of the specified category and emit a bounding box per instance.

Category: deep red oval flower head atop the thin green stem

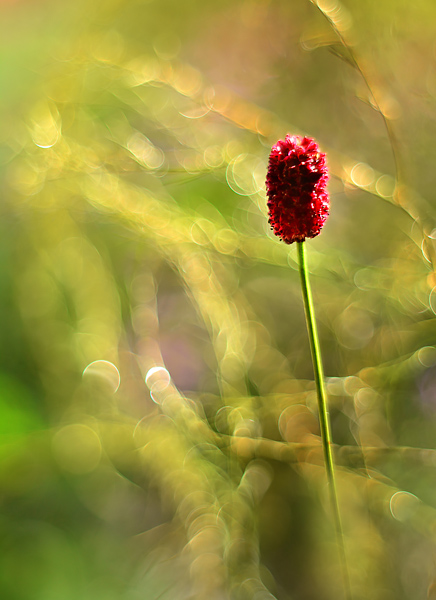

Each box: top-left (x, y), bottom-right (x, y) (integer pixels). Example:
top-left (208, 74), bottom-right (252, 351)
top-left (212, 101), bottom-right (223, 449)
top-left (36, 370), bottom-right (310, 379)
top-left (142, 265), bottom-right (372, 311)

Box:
top-left (266, 135), bottom-right (329, 244)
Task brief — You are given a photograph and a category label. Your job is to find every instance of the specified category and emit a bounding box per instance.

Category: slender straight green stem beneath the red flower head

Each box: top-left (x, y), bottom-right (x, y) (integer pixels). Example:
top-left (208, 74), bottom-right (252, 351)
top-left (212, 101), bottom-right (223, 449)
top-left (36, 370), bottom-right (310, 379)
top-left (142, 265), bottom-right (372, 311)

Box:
top-left (297, 242), bottom-right (351, 600)
